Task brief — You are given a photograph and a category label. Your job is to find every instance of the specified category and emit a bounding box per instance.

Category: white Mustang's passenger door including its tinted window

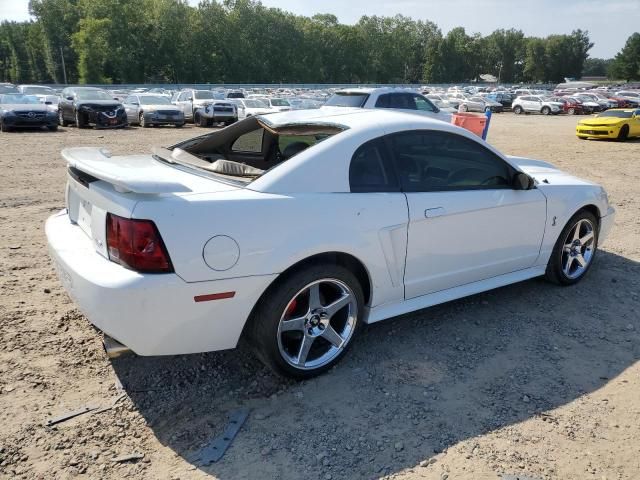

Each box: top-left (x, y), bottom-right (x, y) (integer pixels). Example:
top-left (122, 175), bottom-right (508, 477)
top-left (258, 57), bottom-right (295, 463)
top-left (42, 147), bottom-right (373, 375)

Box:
top-left (388, 130), bottom-right (546, 298)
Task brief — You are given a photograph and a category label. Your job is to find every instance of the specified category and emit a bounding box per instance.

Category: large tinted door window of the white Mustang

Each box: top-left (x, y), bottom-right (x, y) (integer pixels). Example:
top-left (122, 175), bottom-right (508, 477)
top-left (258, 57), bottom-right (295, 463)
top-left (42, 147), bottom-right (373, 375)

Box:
top-left (390, 131), bottom-right (514, 192)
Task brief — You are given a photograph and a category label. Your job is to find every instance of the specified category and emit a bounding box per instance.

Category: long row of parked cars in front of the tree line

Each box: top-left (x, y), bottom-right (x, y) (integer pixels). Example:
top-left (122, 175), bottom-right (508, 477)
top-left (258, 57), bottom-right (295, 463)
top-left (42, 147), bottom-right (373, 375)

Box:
top-left (0, 84), bottom-right (640, 131)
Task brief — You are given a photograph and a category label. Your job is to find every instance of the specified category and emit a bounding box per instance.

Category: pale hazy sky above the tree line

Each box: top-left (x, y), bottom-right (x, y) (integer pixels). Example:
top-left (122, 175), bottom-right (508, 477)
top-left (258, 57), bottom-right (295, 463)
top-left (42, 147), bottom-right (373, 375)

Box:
top-left (0, 0), bottom-right (640, 58)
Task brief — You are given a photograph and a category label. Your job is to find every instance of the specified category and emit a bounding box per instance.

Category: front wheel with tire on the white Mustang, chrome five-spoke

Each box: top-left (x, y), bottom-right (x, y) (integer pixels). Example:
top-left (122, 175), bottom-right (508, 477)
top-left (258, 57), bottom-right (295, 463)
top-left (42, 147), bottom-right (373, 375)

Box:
top-left (546, 210), bottom-right (598, 285)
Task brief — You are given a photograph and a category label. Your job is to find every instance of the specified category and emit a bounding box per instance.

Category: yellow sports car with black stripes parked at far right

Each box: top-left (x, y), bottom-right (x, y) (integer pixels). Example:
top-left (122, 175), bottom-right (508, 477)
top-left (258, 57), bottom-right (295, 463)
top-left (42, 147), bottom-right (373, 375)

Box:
top-left (576, 108), bottom-right (640, 140)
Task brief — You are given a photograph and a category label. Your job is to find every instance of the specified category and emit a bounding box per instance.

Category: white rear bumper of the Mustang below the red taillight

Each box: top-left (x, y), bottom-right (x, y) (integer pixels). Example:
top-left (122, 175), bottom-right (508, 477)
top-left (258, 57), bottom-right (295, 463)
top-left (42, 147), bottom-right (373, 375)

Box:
top-left (45, 211), bottom-right (276, 355)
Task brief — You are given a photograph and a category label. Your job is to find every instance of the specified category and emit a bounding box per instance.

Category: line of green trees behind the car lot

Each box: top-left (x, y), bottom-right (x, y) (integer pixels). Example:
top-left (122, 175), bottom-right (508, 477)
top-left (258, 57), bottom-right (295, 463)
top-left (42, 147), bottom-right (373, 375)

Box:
top-left (0, 0), bottom-right (638, 83)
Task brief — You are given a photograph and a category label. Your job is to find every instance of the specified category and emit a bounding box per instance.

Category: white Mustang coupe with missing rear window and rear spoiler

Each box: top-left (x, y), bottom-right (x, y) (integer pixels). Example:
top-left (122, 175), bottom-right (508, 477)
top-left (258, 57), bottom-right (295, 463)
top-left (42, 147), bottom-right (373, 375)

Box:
top-left (46, 109), bottom-right (615, 378)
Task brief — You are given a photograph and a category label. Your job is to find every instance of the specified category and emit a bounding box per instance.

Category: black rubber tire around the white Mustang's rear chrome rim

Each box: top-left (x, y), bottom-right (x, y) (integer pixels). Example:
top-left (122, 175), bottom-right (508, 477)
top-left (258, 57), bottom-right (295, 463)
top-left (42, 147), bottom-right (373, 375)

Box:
top-left (245, 264), bottom-right (364, 380)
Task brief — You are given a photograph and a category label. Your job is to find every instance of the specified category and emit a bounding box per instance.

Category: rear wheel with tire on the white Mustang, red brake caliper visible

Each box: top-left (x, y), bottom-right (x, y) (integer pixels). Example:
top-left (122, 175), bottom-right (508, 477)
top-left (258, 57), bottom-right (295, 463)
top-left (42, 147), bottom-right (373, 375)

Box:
top-left (247, 265), bottom-right (364, 379)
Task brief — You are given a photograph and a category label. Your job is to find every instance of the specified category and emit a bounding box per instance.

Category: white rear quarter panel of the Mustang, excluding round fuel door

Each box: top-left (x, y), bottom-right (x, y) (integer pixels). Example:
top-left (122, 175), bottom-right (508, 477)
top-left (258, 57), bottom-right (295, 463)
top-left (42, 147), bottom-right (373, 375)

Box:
top-left (133, 189), bottom-right (407, 305)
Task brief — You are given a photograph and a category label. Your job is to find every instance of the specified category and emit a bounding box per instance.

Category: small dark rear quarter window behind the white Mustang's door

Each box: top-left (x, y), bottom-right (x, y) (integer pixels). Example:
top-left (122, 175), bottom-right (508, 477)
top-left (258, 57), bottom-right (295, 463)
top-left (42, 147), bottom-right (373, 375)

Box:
top-left (349, 138), bottom-right (398, 193)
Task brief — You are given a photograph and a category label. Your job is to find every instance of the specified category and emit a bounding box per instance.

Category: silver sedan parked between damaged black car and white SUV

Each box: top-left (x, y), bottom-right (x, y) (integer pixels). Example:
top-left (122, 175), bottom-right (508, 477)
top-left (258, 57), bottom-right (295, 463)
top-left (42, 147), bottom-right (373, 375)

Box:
top-left (122, 93), bottom-right (184, 127)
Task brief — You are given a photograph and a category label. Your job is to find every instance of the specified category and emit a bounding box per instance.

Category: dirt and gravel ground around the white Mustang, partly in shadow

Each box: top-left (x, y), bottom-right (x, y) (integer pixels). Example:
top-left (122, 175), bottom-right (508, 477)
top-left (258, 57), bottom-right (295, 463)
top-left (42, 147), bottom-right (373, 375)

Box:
top-left (0, 114), bottom-right (640, 480)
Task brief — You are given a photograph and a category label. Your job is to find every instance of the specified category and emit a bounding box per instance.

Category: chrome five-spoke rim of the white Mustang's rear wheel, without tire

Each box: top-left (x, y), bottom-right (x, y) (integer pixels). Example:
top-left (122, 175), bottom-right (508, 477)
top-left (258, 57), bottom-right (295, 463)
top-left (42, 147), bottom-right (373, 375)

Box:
top-left (278, 278), bottom-right (358, 370)
